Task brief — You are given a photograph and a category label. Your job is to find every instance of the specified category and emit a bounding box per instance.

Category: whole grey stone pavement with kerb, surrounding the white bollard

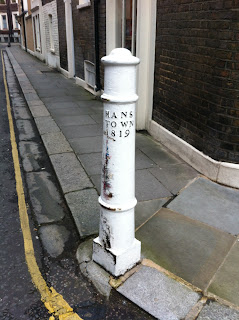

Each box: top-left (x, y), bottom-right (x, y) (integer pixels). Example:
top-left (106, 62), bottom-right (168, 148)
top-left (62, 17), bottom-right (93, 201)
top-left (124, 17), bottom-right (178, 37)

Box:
top-left (7, 46), bottom-right (239, 320)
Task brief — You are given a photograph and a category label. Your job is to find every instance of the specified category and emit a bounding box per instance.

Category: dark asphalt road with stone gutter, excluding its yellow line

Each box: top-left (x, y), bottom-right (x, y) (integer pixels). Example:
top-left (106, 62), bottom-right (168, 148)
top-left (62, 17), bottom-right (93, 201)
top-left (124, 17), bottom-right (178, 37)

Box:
top-left (0, 45), bottom-right (153, 320)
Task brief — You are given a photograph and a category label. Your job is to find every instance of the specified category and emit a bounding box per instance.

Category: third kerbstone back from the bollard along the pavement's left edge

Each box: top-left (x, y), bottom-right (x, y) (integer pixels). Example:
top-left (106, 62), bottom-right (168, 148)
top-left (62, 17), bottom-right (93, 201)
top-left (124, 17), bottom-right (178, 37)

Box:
top-left (41, 131), bottom-right (72, 155)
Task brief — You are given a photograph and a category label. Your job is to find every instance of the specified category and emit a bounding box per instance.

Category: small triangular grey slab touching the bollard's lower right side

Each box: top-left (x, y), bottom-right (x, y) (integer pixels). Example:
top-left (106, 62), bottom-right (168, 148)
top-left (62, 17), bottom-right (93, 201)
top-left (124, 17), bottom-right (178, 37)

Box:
top-left (135, 198), bottom-right (170, 229)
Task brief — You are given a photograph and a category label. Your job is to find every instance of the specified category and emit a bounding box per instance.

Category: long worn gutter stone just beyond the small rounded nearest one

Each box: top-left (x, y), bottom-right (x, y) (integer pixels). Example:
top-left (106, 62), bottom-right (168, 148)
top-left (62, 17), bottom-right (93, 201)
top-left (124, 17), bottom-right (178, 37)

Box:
top-left (26, 171), bottom-right (65, 224)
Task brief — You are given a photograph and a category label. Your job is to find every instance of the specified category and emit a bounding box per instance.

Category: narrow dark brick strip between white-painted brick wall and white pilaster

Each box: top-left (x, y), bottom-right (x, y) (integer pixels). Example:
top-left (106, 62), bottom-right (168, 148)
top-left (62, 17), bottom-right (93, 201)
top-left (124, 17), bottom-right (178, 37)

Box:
top-left (57, 1), bottom-right (68, 70)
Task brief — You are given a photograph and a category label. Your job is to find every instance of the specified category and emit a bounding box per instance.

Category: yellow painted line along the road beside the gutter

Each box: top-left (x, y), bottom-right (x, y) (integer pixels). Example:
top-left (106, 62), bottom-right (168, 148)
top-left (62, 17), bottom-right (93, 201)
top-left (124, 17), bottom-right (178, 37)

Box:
top-left (1, 50), bottom-right (82, 320)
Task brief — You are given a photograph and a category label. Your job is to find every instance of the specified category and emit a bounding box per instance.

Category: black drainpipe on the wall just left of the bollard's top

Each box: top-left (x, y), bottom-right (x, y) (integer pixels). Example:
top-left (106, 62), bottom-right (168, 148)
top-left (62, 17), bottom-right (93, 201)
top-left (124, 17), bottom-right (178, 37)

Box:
top-left (94, 0), bottom-right (101, 92)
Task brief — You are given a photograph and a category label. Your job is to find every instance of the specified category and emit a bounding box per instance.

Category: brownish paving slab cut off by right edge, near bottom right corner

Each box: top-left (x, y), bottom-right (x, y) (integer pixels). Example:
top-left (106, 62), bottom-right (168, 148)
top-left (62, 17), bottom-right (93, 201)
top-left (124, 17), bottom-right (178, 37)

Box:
top-left (208, 241), bottom-right (239, 306)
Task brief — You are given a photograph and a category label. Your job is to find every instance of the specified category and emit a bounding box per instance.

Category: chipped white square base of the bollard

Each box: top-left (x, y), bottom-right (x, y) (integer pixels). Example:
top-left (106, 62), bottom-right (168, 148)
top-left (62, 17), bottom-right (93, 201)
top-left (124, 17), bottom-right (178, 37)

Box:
top-left (93, 237), bottom-right (141, 277)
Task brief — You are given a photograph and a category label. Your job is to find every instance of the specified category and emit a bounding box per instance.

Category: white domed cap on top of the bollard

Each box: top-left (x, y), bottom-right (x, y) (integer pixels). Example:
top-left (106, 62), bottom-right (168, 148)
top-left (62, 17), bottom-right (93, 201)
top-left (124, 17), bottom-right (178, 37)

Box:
top-left (101, 48), bottom-right (140, 65)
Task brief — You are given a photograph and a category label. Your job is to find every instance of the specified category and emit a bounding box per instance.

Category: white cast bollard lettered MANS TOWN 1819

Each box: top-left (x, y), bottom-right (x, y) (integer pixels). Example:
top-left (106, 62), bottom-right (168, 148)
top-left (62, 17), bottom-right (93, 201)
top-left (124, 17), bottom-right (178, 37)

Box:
top-left (93, 48), bottom-right (141, 276)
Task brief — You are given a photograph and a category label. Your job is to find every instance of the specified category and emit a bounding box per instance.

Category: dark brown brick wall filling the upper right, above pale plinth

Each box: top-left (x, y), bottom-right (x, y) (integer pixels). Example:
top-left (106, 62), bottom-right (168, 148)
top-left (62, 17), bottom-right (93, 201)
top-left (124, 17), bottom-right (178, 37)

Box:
top-left (153, 0), bottom-right (239, 163)
